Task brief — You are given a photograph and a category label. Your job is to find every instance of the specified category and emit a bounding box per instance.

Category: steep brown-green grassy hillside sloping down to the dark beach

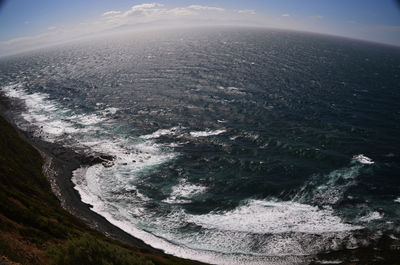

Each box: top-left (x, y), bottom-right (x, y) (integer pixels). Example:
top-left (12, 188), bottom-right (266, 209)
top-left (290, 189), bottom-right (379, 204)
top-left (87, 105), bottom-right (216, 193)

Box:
top-left (0, 116), bottom-right (205, 265)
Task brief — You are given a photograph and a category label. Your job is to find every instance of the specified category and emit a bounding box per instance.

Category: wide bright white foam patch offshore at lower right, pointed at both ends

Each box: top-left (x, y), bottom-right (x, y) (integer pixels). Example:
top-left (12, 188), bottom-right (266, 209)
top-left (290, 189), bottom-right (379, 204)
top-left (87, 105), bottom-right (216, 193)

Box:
top-left (189, 200), bottom-right (360, 234)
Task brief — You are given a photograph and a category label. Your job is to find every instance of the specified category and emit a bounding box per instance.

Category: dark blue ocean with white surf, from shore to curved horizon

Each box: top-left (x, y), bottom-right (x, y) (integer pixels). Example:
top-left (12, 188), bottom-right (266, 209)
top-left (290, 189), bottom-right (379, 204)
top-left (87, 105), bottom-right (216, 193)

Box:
top-left (0, 28), bottom-right (400, 264)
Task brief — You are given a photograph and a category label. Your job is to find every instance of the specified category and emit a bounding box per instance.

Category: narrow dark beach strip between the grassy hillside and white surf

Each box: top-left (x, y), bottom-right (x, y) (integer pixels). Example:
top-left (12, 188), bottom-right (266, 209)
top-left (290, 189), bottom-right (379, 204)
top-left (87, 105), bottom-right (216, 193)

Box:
top-left (0, 95), bottom-right (165, 254)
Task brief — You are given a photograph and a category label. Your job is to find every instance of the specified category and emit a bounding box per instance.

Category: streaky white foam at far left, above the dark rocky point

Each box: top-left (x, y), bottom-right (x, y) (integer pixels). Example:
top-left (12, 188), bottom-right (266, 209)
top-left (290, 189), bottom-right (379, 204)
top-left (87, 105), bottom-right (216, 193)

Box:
top-left (2, 84), bottom-right (174, 172)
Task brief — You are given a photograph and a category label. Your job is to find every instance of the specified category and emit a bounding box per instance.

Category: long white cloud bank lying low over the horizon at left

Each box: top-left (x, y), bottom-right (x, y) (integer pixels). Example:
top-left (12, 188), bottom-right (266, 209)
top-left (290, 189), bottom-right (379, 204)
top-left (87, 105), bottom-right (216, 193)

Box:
top-left (0, 2), bottom-right (266, 54)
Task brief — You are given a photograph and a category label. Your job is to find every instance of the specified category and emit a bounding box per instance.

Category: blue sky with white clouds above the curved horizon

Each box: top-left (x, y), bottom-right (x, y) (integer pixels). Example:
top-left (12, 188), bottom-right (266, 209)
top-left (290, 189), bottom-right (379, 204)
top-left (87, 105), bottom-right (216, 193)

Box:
top-left (0, 0), bottom-right (400, 55)
